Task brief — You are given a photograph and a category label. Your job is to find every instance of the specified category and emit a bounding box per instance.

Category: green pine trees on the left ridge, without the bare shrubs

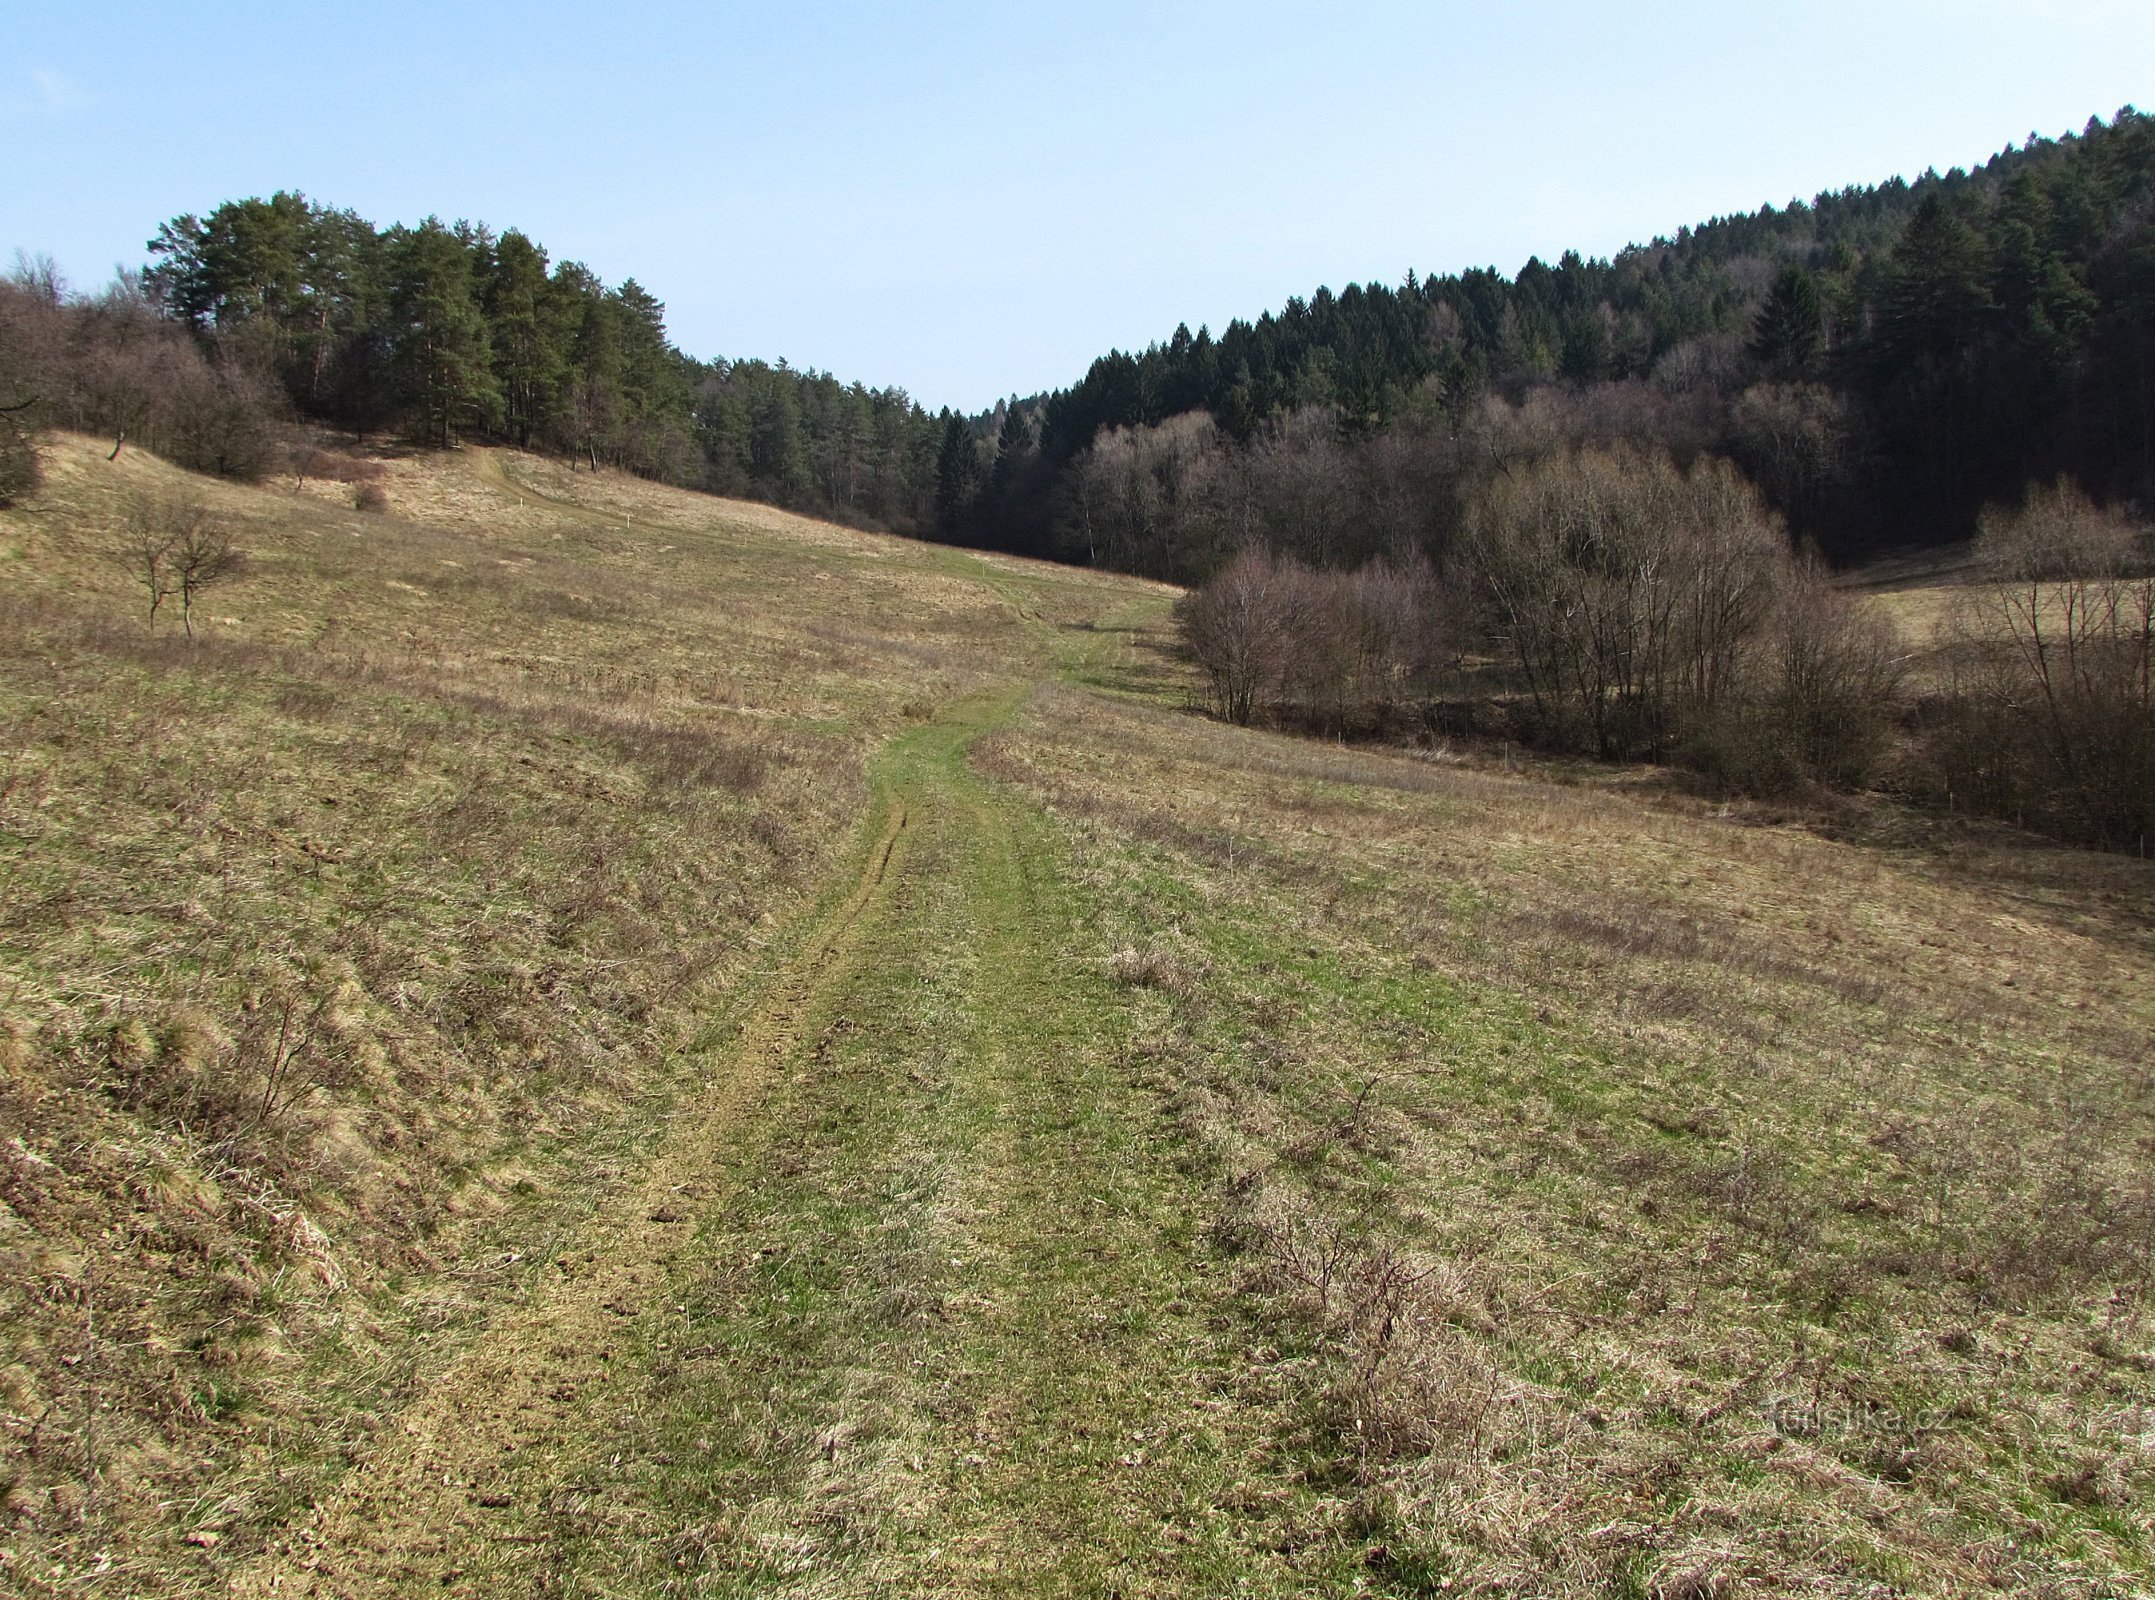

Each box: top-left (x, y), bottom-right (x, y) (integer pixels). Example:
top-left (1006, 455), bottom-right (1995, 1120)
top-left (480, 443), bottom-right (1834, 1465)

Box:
top-left (144, 194), bottom-right (946, 528)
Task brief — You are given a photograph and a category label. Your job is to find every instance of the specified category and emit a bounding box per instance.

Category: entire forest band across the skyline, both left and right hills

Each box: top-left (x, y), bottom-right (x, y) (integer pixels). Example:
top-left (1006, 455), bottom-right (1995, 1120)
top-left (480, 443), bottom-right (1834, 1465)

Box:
top-left (0, 108), bottom-right (2155, 582)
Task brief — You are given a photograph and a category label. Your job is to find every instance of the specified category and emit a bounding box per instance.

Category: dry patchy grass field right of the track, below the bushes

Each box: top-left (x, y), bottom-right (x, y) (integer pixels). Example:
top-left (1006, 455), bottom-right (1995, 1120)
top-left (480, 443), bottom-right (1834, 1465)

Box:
top-left (978, 694), bottom-right (2155, 1594)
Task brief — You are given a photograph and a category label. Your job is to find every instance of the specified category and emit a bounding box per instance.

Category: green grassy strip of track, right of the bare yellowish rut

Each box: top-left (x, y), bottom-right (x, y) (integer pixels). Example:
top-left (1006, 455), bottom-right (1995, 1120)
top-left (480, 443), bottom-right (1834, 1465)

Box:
top-left (487, 707), bottom-right (1351, 1598)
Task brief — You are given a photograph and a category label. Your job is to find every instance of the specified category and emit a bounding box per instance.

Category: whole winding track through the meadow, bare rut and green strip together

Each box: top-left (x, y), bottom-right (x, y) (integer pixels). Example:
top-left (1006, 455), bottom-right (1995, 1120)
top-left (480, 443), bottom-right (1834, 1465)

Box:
top-left (231, 539), bottom-right (1308, 1598)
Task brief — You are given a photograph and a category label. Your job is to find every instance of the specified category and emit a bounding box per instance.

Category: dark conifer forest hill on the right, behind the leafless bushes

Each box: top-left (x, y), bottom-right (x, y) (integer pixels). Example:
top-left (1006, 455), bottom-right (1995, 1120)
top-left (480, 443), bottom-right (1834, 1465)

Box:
top-left (944, 108), bottom-right (2155, 582)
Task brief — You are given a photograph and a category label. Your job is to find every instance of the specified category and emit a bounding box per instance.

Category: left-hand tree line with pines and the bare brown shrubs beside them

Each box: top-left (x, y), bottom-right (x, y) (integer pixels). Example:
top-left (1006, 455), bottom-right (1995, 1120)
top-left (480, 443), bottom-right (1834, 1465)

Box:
top-left (0, 192), bottom-right (950, 530)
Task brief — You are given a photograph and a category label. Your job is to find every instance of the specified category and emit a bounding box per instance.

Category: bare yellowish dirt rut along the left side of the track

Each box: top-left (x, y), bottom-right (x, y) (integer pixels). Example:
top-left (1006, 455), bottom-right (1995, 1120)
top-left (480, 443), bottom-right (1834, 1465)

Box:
top-left (233, 791), bottom-right (907, 1596)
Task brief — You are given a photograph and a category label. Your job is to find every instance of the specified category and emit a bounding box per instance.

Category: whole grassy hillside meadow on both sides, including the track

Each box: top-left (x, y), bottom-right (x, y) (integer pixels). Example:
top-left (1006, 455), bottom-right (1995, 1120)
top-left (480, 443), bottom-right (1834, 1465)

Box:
top-left (0, 440), bottom-right (2155, 1596)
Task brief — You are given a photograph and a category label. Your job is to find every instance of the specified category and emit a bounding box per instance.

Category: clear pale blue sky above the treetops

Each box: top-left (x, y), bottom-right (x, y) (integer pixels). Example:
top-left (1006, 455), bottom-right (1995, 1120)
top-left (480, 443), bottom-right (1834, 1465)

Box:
top-left (0, 0), bottom-right (2155, 410)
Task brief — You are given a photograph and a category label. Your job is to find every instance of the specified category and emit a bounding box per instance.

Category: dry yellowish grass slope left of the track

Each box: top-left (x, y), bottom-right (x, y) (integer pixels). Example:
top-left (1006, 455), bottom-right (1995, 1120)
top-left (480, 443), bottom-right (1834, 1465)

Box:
top-left (0, 436), bottom-right (1142, 1589)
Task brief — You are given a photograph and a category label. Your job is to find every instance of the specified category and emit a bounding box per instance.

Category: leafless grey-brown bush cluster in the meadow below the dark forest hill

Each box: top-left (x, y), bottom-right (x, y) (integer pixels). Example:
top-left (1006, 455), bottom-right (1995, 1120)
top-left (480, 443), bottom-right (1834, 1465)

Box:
top-left (1181, 446), bottom-right (1901, 791)
